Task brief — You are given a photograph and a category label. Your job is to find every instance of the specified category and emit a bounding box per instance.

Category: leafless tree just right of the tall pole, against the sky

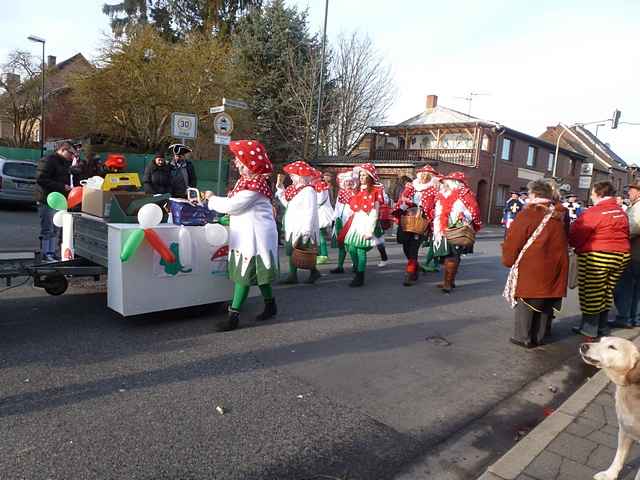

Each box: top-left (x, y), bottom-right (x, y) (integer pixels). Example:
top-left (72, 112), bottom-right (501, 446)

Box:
top-left (326, 32), bottom-right (396, 155)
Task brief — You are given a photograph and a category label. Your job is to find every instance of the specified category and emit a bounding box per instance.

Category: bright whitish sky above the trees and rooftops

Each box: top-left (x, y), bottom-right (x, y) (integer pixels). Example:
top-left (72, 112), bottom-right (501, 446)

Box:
top-left (0, 0), bottom-right (640, 164)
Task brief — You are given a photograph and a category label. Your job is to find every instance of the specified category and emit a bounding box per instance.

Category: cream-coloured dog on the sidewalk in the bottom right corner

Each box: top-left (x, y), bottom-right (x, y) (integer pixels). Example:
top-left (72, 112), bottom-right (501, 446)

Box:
top-left (580, 337), bottom-right (640, 480)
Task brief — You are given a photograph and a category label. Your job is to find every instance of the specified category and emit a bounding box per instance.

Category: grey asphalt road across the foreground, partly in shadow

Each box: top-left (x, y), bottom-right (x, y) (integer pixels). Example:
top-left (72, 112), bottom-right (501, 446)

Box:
top-left (0, 210), bottom-right (596, 480)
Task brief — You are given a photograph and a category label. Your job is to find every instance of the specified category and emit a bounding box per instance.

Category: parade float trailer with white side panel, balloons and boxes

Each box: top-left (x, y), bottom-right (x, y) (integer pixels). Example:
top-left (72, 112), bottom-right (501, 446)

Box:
top-left (0, 156), bottom-right (238, 316)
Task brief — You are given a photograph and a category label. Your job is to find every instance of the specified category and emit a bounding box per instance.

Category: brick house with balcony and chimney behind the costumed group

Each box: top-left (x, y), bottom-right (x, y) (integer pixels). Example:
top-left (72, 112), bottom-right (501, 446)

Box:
top-left (315, 95), bottom-right (586, 224)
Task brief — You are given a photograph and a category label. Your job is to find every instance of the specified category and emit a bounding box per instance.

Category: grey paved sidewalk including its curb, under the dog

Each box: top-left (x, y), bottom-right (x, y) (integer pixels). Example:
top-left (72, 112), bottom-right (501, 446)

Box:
top-left (478, 334), bottom-right (640, 480)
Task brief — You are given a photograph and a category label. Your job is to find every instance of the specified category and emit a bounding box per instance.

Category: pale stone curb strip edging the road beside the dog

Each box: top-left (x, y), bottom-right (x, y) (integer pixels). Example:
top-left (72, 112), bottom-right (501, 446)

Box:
top-left (477, 329), bottom-right (640, 480)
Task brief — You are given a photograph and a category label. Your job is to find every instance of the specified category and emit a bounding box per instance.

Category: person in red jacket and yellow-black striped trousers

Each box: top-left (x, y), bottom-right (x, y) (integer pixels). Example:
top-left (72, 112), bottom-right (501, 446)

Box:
top-left (569, 182), bottom-right (631, 337)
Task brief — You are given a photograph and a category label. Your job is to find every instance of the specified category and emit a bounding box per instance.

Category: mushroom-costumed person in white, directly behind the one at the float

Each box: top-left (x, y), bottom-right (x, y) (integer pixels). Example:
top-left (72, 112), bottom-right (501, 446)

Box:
top-left (276, 160), bottom-right (321, 284)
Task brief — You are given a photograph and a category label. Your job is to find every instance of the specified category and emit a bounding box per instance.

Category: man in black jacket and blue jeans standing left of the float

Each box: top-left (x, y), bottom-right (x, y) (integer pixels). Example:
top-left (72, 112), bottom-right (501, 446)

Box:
top-left (35, 142), bottom-right (76, 261)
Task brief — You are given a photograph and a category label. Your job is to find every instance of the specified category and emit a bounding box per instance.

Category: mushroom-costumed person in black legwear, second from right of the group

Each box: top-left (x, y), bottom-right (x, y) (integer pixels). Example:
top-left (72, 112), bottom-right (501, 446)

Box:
top-left (396, 165), bottom-right (440, 287)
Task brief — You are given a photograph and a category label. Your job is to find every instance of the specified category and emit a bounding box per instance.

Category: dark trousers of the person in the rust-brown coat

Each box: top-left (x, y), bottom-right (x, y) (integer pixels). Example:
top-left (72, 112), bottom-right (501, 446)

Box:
top-left (513, 298), bottom-right (561, 344)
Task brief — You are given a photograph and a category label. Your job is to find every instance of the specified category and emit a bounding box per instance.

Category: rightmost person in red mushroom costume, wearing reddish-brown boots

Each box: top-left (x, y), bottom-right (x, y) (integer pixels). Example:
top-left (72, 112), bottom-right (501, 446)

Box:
top-left (433, 172), bottom-right (482, 293)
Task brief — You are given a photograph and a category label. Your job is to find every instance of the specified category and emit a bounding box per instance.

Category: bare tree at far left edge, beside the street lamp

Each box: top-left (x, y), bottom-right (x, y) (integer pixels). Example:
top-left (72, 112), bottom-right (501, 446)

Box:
top-left (0, 50), bottom-right (42, 147)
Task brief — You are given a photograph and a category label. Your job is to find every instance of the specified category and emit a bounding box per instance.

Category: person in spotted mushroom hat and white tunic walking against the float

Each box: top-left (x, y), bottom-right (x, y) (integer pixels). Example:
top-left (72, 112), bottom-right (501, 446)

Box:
top-left (208, 140), bottom-right (278, 331)
